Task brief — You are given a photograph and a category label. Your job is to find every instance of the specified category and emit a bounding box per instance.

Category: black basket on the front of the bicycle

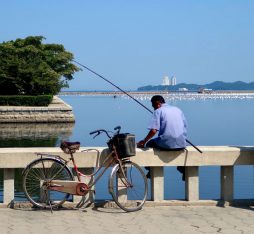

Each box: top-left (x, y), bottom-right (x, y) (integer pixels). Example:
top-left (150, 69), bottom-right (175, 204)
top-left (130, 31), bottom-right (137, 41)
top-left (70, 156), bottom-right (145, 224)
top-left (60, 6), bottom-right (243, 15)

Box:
top-left (112, 133), bottom-right (136, 158)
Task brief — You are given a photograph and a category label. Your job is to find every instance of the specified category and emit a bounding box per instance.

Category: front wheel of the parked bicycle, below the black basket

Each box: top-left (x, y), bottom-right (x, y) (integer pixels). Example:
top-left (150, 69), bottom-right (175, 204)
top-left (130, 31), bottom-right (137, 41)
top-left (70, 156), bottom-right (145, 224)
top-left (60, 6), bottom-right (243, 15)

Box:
top-left (109, 161), bottom-right (148, 212)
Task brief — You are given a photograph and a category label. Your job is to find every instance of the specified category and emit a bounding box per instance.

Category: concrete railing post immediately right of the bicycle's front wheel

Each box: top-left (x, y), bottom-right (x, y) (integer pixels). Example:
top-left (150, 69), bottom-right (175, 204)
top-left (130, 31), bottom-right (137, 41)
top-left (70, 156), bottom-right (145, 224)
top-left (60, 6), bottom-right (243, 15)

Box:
top-left (151, 167), bottom-right (164, 201)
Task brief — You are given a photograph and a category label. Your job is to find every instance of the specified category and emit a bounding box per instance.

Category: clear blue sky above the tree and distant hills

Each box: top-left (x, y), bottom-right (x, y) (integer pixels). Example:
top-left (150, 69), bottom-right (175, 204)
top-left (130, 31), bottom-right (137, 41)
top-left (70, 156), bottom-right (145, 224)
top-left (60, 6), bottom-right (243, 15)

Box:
top-left (0, 0), bottom-right (254, 90)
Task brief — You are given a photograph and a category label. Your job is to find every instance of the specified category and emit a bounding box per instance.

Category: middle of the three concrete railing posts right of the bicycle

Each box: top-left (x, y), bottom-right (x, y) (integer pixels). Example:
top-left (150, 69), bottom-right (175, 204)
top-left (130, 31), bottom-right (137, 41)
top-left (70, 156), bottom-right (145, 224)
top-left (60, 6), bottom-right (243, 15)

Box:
top-left (185, 166), bottom-right (199, 201)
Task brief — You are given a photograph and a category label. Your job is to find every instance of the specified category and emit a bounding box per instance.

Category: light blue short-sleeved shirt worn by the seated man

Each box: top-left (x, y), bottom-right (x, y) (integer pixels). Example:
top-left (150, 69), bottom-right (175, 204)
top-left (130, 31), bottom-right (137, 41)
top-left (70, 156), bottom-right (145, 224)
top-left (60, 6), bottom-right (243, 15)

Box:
top-left (148, 103), bottom-right (187, 149)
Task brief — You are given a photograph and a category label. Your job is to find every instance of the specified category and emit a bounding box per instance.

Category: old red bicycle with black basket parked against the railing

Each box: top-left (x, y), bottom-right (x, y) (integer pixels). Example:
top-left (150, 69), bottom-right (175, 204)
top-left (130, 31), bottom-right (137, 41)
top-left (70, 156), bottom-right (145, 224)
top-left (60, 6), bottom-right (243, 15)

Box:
top-left (22, 126), bottom-right (148, 212)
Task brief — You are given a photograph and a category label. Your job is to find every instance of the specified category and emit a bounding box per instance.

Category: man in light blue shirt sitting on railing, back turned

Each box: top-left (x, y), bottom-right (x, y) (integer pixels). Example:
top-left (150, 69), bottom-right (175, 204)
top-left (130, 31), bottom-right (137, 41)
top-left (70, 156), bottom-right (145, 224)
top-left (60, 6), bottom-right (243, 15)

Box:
top-left (137, 95), bottom-right (187, 180)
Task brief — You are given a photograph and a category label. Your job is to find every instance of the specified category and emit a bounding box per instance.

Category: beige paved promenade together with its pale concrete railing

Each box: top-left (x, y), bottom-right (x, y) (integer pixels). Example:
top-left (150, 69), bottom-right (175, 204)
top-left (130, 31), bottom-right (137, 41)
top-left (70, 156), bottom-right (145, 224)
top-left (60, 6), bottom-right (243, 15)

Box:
top-left (0, 146), bottom-right (254, 234)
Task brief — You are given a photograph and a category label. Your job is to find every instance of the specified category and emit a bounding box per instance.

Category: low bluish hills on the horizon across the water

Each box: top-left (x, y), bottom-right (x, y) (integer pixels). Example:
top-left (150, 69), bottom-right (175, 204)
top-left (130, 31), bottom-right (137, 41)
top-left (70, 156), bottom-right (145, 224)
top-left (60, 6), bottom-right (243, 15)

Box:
top-left (137, 81), bottom-right (254, 91)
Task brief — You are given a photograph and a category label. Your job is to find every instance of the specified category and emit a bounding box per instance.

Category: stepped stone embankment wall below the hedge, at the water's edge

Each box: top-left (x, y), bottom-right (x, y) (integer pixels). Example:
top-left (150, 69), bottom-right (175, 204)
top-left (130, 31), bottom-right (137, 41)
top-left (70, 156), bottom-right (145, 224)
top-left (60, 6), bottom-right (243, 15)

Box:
top-left (0, 96), bottom-right (75, 123)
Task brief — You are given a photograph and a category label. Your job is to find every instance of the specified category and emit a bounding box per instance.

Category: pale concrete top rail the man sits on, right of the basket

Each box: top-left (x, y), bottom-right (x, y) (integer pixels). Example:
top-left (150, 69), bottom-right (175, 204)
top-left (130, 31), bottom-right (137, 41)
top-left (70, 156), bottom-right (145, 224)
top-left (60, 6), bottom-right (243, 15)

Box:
top-left (132, 146), bottom-right (254, 167)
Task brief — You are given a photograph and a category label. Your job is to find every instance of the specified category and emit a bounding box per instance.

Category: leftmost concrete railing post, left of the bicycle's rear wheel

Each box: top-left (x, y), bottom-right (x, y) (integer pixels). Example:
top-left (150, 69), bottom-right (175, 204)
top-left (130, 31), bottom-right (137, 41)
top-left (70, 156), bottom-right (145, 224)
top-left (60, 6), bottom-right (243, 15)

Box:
top-left (3, 168), bottom-right (14, 204)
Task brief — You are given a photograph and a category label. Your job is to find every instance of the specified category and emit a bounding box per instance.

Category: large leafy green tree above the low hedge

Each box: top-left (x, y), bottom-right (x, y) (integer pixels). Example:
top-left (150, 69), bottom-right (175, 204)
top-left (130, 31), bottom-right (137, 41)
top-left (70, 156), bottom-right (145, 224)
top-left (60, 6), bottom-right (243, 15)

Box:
top-left (0, 36), bottom-right (80, 95)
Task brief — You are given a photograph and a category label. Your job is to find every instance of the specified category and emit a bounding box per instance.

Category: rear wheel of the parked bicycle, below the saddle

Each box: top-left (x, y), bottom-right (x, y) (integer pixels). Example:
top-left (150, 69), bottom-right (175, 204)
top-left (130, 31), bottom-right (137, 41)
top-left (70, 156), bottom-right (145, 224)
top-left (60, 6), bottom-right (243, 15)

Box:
top-left (22, 157), bottom-right (74, 209)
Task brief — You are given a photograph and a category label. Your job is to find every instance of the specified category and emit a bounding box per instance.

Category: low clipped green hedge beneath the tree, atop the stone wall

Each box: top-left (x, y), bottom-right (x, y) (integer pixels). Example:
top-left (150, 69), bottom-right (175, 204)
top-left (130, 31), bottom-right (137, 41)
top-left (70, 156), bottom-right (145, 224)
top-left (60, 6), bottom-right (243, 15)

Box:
top-left (0, 95), bottom-right (53, 106)
